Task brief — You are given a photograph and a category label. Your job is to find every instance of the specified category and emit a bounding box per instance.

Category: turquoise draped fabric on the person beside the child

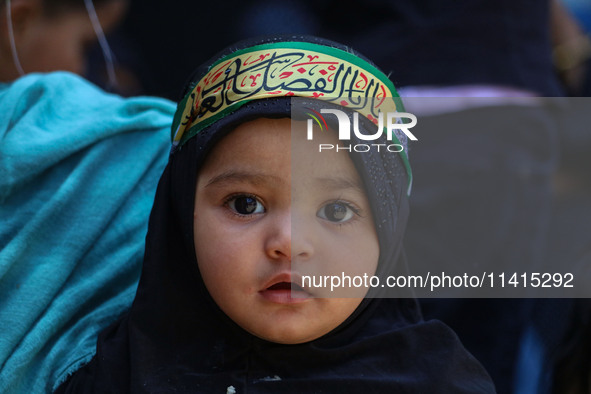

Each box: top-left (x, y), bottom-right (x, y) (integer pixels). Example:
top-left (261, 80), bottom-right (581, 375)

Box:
top-left (0, 72), bottom-right (175, 393)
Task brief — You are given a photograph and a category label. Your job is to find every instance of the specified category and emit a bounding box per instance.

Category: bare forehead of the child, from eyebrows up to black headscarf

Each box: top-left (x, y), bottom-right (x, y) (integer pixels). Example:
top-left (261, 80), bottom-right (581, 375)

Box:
top-left (202, 117), bottom-right (362, 185)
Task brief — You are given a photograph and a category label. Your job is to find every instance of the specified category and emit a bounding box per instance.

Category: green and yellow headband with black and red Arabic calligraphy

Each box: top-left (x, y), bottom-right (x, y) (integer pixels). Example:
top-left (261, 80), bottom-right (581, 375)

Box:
top-left (172, 42), bottom-right (412, 192)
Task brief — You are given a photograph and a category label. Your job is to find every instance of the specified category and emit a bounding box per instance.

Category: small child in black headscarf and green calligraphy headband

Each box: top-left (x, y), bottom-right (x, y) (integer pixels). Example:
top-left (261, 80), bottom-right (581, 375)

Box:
top-left (58, 37), bottom-right (494, 393)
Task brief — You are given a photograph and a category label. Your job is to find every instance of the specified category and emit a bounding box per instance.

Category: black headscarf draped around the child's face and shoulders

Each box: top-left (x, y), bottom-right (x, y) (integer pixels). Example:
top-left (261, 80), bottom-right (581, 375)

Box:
top-left (58, 37), bottom-right (494, 393)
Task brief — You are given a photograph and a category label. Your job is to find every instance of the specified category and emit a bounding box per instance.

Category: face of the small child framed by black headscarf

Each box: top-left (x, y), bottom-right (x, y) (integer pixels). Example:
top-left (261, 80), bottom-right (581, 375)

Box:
top-left (194, 119), bottom-right (379, 344)
